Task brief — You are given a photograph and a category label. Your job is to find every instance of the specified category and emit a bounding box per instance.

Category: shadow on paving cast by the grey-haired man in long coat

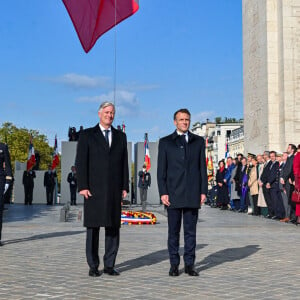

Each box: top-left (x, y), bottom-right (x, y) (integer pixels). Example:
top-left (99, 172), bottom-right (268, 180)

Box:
top-left (116, 244), bottom-right (207, 272)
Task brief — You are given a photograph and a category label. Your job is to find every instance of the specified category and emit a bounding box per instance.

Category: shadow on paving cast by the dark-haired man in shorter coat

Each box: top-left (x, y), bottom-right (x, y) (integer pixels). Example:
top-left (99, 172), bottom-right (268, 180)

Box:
top-left (195, 245), bottom-right (261, 272)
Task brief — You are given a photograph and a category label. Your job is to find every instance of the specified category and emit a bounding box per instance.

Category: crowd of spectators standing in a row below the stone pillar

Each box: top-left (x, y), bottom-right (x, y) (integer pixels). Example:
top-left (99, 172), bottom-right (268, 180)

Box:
top-left (207, 144), bottom-right (300, 225)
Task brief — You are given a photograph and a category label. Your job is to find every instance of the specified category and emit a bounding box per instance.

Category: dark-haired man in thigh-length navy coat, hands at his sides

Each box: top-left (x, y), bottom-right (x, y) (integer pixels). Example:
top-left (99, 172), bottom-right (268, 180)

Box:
top-left (157, 109), bottom-right (208, 276)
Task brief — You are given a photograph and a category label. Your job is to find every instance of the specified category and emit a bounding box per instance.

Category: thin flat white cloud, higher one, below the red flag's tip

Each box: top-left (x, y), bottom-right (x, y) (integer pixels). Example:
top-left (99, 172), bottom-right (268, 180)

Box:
top-left (42, 73), bottom-right (111, 88)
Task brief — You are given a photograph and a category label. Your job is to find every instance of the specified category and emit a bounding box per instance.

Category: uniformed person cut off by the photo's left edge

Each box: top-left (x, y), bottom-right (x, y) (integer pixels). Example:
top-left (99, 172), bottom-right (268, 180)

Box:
top-left (0, 143), bottom-right (12, 246)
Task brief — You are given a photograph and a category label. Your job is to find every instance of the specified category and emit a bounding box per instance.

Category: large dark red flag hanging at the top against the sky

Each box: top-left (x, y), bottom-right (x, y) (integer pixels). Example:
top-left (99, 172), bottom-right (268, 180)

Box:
top-left (63, 0), bottom-right (139, 52)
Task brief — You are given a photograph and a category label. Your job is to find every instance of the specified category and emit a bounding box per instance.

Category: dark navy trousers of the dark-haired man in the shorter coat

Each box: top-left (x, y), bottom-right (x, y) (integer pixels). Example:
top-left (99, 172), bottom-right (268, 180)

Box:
top-left (168, 208), bottom-right (198, 266)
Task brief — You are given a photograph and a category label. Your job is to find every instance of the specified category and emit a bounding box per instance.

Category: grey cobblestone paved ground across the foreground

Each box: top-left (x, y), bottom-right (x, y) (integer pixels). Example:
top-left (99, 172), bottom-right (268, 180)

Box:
top-left (0, 205), bottom-right (300, 300)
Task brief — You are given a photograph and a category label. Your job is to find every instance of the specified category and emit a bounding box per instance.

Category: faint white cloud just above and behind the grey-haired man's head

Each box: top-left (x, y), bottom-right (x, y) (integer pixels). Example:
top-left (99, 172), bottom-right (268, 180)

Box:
top-left (76, 90), bottom-right (139, 117)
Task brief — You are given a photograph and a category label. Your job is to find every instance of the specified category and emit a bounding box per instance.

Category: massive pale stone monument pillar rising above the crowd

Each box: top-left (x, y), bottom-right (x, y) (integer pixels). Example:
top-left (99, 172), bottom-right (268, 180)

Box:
top-left (243, 0), bottom-right (300, 153)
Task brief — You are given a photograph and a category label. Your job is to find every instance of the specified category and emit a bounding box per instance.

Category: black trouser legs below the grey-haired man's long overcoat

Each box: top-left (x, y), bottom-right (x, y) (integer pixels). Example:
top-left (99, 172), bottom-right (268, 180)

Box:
top-left (86, 227), bottom-right (120, 269)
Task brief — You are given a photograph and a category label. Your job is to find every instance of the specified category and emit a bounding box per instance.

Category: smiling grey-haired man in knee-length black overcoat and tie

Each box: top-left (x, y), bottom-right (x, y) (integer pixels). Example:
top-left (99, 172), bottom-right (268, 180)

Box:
top-left (76, 102), bottom-right (129, 277)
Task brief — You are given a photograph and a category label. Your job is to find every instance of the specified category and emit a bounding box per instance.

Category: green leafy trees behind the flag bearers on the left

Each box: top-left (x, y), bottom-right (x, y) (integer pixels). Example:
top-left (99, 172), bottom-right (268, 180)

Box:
top-left (0, 122), bottom-right (61, 182)
